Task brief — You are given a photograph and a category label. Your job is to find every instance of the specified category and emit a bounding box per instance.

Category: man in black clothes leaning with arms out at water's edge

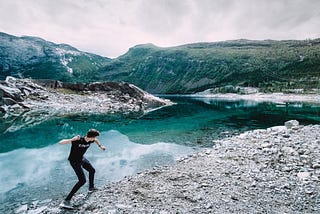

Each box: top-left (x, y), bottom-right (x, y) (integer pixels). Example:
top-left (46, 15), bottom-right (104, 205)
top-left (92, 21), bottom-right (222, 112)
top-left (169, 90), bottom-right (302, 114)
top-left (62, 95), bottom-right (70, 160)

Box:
top-left (59, 129), bottom-right (106, 209)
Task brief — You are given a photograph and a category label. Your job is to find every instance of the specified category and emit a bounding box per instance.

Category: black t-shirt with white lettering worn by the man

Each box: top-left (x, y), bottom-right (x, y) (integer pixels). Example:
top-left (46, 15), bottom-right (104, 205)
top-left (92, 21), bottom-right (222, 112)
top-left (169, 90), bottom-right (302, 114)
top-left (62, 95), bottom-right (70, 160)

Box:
top-left (68, 137), bottom-right (94, 161)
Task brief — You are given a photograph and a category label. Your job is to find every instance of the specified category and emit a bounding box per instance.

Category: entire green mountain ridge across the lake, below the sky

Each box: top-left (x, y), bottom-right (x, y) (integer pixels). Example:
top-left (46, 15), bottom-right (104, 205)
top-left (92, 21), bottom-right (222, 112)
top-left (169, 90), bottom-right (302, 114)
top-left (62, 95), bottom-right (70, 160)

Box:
top-left (0, 33), bottom-right (320, 94)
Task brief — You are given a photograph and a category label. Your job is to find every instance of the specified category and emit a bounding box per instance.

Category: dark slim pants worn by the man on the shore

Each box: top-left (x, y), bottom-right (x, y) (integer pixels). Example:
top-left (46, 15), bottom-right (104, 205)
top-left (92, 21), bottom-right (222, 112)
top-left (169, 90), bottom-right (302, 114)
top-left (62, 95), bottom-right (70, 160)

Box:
top-left (66, 158), bottom-right (96, 201)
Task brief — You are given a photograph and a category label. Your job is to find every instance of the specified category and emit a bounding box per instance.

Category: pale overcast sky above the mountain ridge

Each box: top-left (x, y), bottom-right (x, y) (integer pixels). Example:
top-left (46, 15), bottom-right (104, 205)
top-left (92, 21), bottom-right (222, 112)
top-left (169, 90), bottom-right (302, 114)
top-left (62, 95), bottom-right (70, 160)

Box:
top-left (0, 0), bottom-right (320, 58)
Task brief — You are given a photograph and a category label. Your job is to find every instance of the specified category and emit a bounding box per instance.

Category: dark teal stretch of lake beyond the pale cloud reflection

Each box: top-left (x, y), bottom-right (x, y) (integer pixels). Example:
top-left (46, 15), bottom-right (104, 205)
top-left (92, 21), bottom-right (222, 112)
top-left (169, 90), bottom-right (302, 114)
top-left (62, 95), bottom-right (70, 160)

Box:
top-left (0, 97), bottom-right (320, 153)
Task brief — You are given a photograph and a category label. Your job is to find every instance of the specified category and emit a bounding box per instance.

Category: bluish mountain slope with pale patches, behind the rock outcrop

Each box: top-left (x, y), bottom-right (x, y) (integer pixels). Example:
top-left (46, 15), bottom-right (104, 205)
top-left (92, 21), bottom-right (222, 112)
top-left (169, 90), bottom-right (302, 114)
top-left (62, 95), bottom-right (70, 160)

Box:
top-left (0, 32), bottom-right (111, 81)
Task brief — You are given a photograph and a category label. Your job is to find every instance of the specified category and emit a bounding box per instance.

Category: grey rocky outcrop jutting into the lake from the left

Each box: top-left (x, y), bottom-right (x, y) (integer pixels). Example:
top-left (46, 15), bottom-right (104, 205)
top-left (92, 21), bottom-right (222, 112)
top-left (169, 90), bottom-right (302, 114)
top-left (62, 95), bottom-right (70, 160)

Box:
top-left (0, 77), bottom-right (172, 131)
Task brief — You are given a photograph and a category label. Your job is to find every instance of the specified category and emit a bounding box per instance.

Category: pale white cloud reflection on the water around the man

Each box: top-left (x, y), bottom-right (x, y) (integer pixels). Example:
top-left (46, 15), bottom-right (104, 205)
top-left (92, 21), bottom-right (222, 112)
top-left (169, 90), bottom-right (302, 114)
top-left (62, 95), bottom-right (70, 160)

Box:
top-left (0, 130), bottom-right (195, 213)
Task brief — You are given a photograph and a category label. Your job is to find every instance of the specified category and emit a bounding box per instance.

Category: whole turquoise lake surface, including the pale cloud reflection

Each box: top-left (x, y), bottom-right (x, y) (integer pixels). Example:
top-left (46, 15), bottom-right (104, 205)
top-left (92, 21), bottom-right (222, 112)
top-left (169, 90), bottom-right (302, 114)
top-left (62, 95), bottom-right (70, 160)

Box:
top-left (0, 97), bottom-right (320, 212)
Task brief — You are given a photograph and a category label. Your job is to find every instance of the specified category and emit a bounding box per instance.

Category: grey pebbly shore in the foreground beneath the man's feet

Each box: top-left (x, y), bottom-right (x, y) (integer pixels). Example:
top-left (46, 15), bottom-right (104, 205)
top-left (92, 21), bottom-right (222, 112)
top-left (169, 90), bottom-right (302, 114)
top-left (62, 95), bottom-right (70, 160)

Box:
top-left (20, 121), bottom-right (320, 214)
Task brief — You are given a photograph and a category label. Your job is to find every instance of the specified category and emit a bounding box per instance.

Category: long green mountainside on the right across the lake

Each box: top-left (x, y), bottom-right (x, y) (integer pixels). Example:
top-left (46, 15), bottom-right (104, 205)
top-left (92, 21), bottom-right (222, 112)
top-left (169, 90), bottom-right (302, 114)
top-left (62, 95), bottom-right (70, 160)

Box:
top-left (100, 39), bottom-right (320, 93)
